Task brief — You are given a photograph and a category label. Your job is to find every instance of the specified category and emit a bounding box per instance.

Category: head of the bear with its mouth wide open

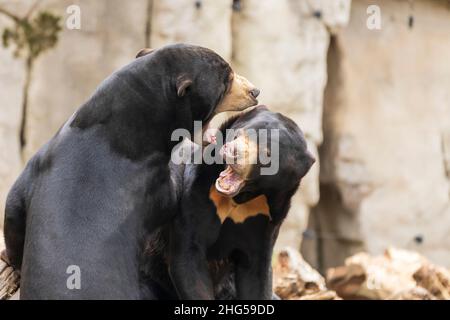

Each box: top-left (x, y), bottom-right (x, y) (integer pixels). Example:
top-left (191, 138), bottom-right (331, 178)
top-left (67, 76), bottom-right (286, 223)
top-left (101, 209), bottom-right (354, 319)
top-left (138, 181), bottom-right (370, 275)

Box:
top-left (215, 106), bottom-right (315, 203)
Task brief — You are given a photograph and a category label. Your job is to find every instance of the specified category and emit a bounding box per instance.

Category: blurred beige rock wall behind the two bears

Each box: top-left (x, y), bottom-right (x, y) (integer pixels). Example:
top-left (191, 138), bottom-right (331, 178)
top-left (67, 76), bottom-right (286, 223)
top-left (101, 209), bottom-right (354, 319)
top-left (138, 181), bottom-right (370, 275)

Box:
top-left (0, 0), bottom-right (450, 272)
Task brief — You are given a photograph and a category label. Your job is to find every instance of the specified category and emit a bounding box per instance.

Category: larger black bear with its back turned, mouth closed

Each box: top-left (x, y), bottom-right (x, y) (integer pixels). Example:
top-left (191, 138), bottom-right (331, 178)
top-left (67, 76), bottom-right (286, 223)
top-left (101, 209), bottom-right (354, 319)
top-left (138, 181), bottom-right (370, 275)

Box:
top-left (4, 44), bottom-right (259, 299)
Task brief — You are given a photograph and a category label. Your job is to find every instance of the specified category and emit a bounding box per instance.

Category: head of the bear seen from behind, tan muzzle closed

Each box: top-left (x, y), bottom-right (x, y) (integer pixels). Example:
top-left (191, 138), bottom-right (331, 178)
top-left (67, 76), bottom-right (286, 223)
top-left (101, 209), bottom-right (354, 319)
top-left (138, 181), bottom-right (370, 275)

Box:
top-left (136, 44), bottom-right (260, 121)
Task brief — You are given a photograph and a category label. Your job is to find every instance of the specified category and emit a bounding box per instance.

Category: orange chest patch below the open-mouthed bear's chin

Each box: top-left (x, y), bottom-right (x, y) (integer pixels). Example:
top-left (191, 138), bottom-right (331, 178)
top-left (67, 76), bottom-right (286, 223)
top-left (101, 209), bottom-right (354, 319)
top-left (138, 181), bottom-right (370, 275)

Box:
top-left (209, 186), bottom-right (270, 223)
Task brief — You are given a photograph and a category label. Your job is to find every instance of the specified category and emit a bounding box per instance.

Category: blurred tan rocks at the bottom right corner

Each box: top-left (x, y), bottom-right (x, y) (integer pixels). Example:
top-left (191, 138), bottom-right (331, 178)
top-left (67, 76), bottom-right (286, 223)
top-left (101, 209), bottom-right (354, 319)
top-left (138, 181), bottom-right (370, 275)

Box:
top-left (327, 248), bottom-right (450, 300)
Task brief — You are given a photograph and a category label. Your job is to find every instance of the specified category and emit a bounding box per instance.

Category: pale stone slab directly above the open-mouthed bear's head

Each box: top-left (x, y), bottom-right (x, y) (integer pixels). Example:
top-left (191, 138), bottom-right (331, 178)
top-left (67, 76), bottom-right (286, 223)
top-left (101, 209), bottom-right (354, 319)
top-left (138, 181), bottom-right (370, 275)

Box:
top-left (233, 0), bottom-right (329, 143)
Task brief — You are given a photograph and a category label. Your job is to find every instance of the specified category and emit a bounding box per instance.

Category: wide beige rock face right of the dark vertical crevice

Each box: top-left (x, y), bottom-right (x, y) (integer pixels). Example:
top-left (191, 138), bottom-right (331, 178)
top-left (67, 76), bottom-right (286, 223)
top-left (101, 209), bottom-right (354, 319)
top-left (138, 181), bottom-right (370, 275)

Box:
top-left (303, 0), bottom-right (450, 271)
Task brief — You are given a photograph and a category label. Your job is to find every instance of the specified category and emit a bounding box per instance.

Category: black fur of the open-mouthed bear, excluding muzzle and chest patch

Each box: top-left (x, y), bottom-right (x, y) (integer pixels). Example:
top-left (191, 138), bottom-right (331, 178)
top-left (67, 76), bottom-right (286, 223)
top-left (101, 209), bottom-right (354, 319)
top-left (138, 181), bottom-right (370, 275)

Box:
top-left (142, 107), bottom-right (314, 299)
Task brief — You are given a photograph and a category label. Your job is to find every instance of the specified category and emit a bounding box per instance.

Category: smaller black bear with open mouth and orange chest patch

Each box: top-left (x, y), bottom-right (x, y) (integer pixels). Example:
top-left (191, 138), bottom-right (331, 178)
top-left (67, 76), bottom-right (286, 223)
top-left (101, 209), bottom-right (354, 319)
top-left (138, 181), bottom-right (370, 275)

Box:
top-left (141, 106), bottom-right (315, 299)
